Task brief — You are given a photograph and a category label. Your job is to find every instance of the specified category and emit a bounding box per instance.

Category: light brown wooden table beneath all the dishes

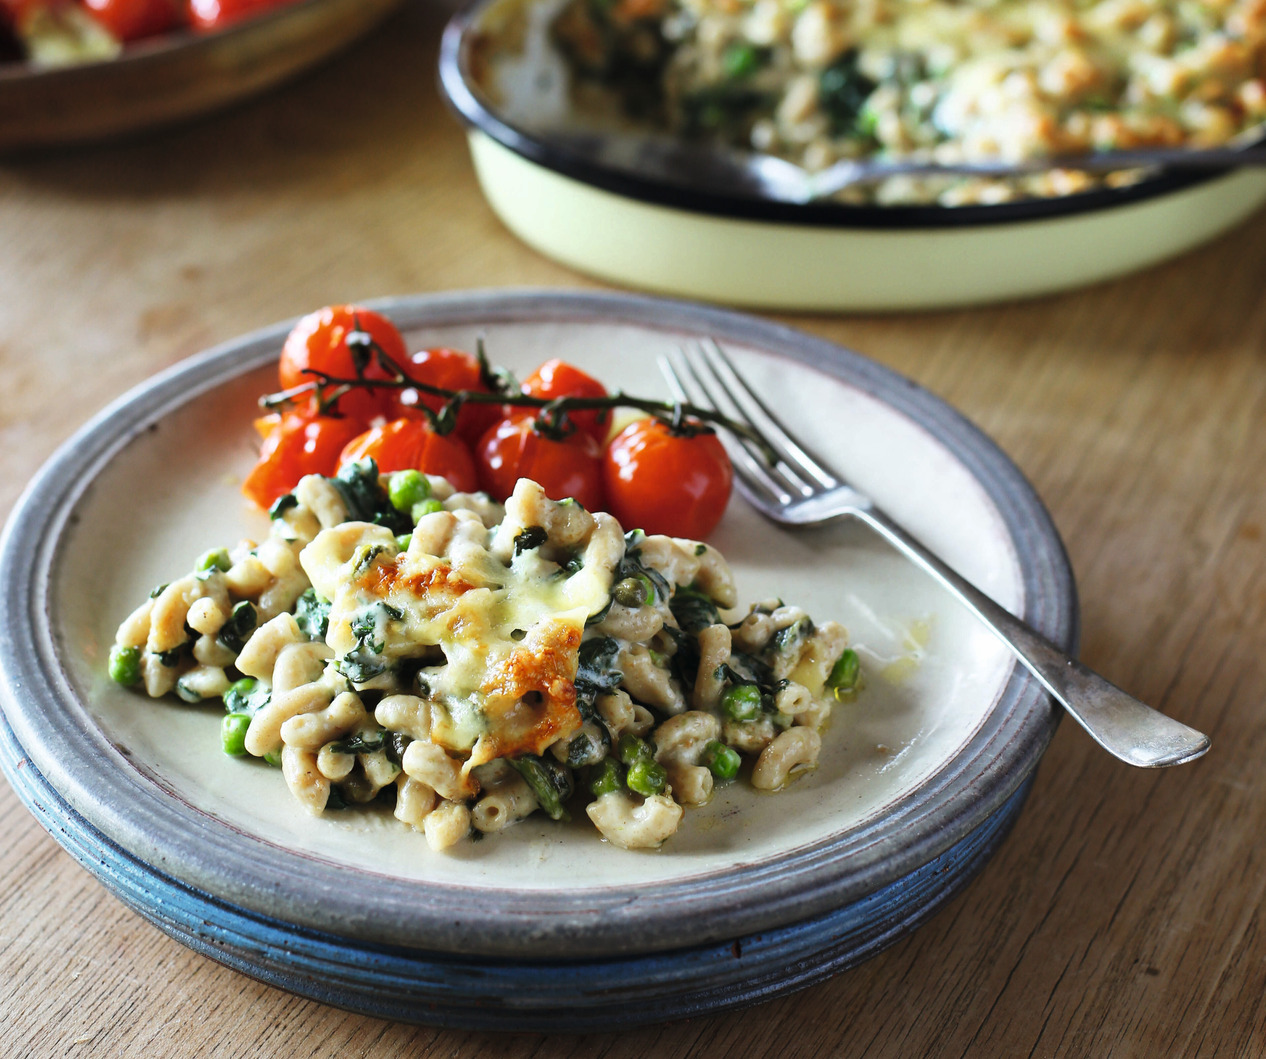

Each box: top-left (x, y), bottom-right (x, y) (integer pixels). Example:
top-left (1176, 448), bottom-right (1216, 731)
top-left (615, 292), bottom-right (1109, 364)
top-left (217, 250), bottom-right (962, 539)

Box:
top-left (0, 5), bottom-right (1266, 1059)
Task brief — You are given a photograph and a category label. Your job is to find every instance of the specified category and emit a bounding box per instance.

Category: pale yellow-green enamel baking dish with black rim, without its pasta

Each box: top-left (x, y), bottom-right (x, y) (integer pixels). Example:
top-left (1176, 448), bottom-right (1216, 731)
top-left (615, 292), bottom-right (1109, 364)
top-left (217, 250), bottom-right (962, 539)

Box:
top-left (439, 0), bottom-right (1266, 310)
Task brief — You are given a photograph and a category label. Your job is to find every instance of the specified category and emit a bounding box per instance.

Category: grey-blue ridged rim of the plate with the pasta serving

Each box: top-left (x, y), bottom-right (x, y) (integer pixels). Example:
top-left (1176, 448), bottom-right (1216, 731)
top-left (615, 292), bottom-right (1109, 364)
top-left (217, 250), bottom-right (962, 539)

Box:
top-left (0, 289), bottom-right (1077, 958)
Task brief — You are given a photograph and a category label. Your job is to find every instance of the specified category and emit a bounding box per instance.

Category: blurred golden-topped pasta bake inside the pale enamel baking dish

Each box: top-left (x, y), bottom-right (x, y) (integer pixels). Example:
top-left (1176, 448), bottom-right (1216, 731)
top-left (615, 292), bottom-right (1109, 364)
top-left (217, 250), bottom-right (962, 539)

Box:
top-left (555, 0), bottom-right (1266, 205)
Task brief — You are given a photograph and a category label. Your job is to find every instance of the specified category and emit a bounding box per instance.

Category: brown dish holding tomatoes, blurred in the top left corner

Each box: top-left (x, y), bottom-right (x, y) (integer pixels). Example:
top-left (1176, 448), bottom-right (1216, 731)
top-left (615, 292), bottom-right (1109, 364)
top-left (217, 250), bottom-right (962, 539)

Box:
top-left (0, 0), bottom-right (400, 151)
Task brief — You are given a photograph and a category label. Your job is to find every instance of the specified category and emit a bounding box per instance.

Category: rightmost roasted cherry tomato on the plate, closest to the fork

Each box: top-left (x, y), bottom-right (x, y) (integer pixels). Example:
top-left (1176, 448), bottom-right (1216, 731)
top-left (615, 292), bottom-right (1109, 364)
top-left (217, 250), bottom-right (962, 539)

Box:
top-left (603, 418), bottom-right (734, 541)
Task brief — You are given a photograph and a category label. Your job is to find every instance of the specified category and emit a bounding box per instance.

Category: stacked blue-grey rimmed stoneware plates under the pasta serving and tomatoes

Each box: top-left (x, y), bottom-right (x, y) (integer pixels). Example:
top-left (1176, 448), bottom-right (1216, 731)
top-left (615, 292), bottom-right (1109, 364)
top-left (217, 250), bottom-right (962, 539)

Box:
top-left (0, 291), bottom-right (1076, 1026)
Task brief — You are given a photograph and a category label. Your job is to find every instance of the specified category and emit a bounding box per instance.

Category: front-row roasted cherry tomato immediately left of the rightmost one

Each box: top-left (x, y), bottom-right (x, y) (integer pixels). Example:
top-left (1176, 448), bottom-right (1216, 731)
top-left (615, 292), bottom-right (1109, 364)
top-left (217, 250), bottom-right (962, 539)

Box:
top-left (476, 414), bottom-right (603, 510)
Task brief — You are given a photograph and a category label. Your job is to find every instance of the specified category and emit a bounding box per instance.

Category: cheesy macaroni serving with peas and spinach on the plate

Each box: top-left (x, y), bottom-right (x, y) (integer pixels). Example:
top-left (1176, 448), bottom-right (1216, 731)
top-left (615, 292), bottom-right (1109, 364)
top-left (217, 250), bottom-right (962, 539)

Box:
top-left (116, 465), bottom-right (847, 850)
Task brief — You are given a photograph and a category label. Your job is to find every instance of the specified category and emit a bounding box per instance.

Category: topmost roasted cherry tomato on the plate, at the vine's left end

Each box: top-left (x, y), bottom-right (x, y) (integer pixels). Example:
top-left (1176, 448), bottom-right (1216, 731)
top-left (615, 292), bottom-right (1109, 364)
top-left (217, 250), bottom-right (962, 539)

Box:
top-left (277, 305), bottom-right (409, 419)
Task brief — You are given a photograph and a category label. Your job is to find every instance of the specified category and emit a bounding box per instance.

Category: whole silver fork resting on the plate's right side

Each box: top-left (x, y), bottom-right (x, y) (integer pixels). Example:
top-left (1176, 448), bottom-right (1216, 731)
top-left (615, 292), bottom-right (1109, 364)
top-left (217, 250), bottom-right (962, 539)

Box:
top-left (660, 341), bottom-right (1209, 768)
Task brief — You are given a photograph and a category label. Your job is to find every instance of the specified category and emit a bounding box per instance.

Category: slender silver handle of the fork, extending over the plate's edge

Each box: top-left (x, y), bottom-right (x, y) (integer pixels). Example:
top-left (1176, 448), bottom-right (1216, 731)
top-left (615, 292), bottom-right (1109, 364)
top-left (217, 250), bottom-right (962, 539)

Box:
top-left (855, 508), bottom-right (1209, 769)
